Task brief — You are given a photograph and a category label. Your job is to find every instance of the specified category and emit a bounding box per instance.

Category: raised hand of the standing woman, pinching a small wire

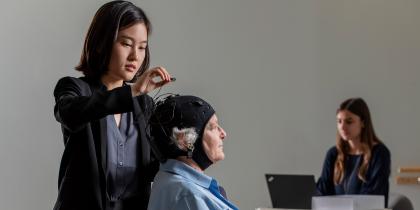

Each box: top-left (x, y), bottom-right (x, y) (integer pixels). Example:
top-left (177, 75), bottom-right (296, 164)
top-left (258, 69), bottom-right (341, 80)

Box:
top-left (131, 66), bottom-right (171, 96)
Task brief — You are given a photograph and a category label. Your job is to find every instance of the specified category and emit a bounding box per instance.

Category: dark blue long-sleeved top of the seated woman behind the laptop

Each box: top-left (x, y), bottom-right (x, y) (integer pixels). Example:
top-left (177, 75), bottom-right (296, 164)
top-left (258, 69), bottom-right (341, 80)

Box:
top-left (317, 144), bottom-right (391, 206)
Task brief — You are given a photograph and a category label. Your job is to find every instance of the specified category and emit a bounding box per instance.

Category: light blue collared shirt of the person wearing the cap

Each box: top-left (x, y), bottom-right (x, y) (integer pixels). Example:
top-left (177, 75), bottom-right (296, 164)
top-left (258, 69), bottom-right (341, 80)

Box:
top-left (147, 159), bottom-right (238, 210)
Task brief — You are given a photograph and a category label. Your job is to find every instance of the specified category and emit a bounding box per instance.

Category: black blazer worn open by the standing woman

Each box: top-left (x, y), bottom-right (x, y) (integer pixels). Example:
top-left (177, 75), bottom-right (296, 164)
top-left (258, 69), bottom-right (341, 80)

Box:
top-left (54, 77), bottom-right (159, 210)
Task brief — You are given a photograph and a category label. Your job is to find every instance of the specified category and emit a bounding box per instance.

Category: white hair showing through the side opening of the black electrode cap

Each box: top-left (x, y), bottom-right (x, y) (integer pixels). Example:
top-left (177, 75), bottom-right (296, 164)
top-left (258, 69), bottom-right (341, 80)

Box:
top-left (171, 127), bottom-right (198, 150)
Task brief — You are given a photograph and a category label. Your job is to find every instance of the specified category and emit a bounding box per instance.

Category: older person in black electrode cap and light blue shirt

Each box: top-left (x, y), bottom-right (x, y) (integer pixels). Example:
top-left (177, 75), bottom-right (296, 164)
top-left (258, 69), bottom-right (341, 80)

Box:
top-left (148, 96), bottom-right (238, 210)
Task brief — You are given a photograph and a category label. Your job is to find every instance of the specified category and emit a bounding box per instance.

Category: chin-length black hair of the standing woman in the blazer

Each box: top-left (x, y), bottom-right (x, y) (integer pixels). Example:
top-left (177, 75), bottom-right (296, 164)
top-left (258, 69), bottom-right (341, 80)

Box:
top-left (76, 1), bottom-right (151, 80)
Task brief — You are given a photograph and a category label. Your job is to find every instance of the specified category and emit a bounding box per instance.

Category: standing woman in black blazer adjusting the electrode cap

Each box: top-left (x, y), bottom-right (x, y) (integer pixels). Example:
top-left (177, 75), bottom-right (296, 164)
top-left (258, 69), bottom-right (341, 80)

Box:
top-left (54, 1), bottom-right (171, 210)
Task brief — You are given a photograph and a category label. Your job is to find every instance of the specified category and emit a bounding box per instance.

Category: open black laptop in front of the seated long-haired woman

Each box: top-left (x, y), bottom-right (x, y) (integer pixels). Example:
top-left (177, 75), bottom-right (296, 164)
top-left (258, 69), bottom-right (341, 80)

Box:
top-left (265, 174), bottom-right (316, 209)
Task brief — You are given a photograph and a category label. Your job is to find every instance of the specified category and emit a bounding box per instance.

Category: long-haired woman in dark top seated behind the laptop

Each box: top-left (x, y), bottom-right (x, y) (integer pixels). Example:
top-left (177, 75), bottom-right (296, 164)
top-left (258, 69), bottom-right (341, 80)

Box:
top-left (317, 98), bottom-right (391, 206)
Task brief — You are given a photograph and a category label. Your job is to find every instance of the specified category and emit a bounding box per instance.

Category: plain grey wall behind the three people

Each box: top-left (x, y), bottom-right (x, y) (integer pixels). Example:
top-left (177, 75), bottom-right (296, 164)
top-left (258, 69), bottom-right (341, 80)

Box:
top-left (0, 0), bottom-right (420, 210)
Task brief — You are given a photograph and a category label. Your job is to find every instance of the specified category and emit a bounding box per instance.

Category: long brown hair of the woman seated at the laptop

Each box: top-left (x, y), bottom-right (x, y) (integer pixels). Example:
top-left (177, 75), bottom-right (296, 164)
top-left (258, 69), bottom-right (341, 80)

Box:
top-left (334, 98), bottom-right (381, 185)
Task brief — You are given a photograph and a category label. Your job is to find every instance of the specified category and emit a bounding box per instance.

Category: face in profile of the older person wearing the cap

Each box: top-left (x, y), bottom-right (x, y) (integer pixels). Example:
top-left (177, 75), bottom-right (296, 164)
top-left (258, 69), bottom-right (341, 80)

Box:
top-left (203, 114), bottom-right (226, 163)
